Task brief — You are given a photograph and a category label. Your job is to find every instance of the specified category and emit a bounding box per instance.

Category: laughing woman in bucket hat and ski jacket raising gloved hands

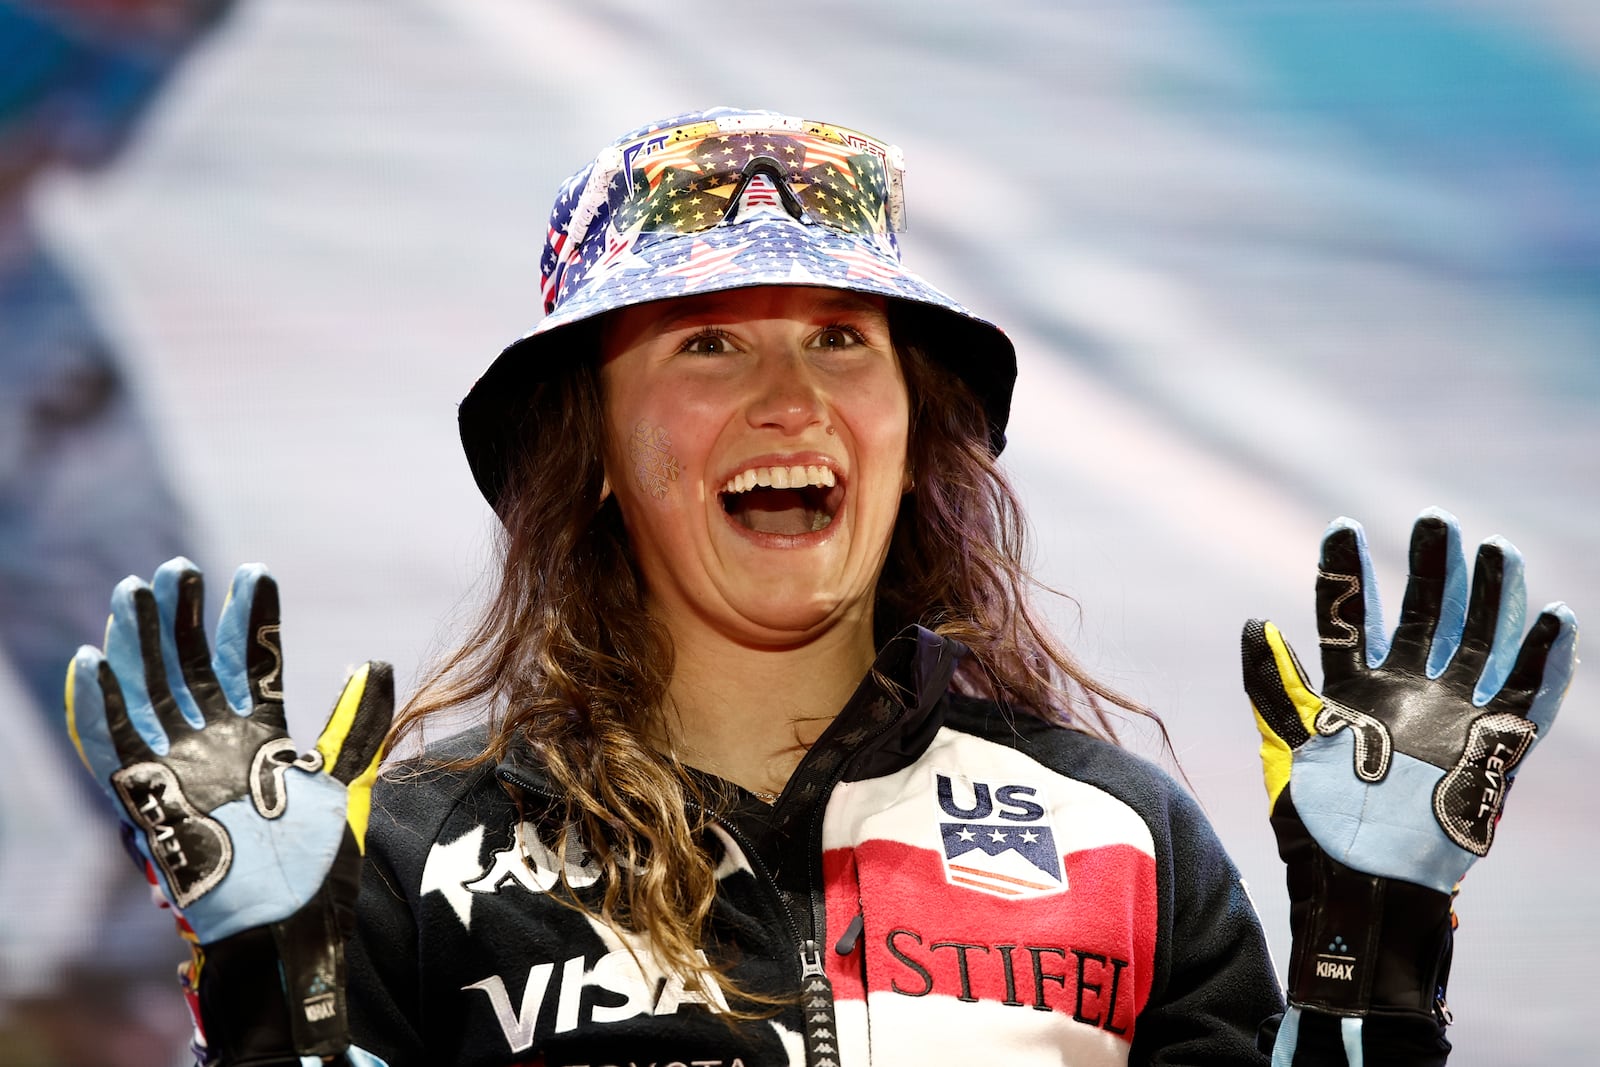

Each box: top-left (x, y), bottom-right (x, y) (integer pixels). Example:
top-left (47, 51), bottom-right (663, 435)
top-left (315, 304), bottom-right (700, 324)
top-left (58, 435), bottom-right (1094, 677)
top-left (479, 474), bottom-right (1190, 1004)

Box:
top-left (59, 109), bottom-right (1574, 1067)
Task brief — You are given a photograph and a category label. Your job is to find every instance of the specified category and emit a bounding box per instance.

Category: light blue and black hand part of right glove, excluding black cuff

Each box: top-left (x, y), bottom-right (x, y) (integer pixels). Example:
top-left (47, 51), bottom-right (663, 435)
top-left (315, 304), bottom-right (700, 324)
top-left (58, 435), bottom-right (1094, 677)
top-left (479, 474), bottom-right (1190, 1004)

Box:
top-left (1245, 509), bottom-right (1578, 893)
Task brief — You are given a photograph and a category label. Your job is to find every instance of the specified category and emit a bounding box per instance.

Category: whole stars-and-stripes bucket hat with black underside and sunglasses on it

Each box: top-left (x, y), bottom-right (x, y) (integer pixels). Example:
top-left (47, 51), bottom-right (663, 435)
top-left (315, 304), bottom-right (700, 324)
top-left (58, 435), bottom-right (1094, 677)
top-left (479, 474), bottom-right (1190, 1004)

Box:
top-left (458, 107), bottom-right (1016, 506)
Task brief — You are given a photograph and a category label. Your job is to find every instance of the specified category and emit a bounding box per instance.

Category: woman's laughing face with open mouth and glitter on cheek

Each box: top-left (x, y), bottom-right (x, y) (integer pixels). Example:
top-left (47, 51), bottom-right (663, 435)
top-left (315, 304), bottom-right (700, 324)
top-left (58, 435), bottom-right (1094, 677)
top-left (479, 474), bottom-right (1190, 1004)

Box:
top-left (602, 286), bottom-right (910, 648)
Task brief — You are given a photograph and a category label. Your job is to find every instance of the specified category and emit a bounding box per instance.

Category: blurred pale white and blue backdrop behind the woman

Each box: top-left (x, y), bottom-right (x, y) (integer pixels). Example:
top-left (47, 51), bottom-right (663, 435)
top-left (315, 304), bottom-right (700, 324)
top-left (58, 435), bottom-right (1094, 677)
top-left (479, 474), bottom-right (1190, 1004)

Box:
top-left (0, 0), bottom-right (1600, 1067)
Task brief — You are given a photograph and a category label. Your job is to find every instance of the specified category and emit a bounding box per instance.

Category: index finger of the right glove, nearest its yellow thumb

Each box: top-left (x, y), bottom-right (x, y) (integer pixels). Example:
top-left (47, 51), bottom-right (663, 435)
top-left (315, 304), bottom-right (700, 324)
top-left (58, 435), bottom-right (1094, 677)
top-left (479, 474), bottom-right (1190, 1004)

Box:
top-left (1317, 517), bottom-right (1389, 686)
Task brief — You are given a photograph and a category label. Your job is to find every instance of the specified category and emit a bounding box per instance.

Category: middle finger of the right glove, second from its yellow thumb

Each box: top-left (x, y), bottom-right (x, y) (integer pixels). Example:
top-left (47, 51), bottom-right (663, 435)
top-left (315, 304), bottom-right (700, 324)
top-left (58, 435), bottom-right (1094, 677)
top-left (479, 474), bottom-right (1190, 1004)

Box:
top-left (1384, 507), bottom-right (1467, 678)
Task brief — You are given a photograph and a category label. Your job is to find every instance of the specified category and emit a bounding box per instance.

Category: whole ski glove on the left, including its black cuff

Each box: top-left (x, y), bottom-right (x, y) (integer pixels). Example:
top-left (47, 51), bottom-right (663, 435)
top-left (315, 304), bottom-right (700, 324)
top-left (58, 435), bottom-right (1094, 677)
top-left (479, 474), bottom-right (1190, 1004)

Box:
top-left (66, 558), bottom-right (394, 1067)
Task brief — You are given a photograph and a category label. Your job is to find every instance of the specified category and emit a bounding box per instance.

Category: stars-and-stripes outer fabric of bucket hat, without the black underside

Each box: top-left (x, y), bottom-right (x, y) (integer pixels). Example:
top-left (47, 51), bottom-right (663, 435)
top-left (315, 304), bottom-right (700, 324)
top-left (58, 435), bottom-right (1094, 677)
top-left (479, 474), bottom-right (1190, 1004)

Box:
top-left (533, 109), bottom-right (970, 334)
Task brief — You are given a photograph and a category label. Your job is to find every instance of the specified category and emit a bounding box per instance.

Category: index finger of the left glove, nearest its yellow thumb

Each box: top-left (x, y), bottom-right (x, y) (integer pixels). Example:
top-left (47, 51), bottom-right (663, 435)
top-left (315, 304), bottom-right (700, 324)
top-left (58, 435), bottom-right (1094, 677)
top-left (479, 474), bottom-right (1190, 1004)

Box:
top-left (214, 563), bottom-right (286, 729)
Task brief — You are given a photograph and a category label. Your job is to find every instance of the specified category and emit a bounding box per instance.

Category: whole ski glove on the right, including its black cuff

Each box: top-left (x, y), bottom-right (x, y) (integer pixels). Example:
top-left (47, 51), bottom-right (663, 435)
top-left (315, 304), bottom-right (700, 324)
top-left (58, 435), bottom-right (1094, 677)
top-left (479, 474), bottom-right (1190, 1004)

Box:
top-left (1243, 509), bottom-right (1578, 1062)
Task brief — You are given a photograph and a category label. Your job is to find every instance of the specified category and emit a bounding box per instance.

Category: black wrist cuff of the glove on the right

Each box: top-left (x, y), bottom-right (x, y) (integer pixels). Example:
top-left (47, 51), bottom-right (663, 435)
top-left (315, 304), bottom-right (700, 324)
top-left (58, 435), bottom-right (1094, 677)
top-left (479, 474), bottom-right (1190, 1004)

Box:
top-left (1272, 790), bottom-right (1453, 1029)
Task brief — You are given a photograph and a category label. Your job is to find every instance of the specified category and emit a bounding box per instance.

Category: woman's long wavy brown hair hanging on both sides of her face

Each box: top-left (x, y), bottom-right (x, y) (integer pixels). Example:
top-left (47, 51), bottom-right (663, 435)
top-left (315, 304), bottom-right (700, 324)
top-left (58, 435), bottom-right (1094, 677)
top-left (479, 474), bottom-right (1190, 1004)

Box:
top-left (394, 306), bottom-right (1165, 1014)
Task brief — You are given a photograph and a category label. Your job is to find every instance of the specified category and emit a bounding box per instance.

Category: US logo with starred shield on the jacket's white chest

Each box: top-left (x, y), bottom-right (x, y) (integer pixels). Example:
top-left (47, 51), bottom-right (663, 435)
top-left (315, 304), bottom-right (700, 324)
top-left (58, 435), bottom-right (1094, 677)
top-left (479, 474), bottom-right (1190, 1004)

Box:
top-left (933, 771), bottom-right (1067, 899)
